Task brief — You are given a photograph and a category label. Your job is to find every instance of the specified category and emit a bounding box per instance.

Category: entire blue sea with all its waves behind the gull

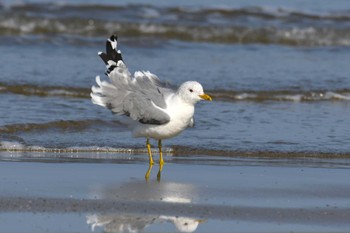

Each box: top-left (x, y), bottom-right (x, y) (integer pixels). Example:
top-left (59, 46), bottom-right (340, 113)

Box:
top-left (0, 0), bottom-right (350, 154)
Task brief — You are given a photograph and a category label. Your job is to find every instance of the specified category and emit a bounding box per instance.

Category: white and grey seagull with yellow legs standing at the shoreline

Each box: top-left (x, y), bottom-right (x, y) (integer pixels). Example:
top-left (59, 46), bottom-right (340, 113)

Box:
top-left (91, 35), bottom-right (212, 168)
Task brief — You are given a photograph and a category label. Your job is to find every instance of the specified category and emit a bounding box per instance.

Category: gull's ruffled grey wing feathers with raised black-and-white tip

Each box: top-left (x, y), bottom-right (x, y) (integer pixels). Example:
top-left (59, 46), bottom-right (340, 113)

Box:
top-left (91, 36), bottom-right (174, 125)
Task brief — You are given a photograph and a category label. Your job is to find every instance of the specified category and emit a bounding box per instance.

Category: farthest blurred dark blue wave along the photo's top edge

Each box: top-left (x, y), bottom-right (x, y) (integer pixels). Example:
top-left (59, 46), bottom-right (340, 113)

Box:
top-left (0, 3), bottom-right (350, 22)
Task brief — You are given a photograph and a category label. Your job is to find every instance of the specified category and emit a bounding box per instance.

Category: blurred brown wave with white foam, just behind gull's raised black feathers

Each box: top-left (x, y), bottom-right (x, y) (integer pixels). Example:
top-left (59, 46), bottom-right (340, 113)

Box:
top-left (0, 19), bottom-right (350, 46)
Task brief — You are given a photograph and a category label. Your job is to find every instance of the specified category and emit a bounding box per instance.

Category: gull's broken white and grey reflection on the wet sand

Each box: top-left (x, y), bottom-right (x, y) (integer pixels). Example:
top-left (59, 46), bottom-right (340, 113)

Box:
top-left (87, 181), bottom-right (204, 233)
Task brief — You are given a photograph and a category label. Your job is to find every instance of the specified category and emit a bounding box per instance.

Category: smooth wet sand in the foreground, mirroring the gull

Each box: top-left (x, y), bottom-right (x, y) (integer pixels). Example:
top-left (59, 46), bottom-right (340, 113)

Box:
top-left (0, 152), bottom-right (350, 232)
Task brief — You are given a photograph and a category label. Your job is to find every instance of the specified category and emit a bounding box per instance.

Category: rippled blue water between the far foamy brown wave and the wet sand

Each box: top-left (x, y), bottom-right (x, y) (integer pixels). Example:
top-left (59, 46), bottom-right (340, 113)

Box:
top-left (0, 38), bottom-right (350, 153)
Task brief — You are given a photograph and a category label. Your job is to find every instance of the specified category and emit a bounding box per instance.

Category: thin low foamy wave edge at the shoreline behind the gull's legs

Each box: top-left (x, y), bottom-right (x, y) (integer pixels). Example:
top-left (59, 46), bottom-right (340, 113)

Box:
top-left (0, 141), bottom-right (350, 160)
